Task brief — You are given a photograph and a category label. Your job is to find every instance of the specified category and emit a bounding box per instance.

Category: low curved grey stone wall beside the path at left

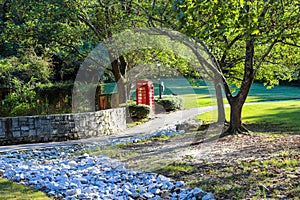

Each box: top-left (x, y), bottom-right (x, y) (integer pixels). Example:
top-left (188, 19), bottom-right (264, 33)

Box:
top-left (0, 108), bottom-right (126, 145)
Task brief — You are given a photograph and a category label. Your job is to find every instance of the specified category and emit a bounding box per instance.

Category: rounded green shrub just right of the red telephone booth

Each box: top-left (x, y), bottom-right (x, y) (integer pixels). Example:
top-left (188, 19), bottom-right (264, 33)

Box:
top-left (155, 95), bottom-right (183, 111)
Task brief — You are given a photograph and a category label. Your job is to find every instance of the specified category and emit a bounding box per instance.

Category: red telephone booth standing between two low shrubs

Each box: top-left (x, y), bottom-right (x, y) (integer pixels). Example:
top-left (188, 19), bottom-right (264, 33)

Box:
top-left (136, 80), bottom-right (155, 112)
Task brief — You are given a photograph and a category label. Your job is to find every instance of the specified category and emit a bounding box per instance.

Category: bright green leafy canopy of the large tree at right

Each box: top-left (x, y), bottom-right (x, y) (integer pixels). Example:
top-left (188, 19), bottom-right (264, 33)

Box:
top-left (173, 0), bottom-right (300, 88)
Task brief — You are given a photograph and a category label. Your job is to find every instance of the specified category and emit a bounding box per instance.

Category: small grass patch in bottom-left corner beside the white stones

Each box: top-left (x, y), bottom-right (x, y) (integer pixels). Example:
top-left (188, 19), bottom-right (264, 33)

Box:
top-left (0, 178), bottom-right (50, 200)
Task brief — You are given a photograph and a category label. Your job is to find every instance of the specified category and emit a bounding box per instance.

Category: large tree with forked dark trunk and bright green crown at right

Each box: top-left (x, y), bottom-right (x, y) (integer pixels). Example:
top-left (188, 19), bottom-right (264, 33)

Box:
top-left (150, 0), bottom-right (300, 134)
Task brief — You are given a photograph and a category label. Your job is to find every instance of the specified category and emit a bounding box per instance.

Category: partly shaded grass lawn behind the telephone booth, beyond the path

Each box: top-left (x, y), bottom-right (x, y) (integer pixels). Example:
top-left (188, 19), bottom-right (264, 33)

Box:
top-left (130, 78), bottom-right (300, 109)
